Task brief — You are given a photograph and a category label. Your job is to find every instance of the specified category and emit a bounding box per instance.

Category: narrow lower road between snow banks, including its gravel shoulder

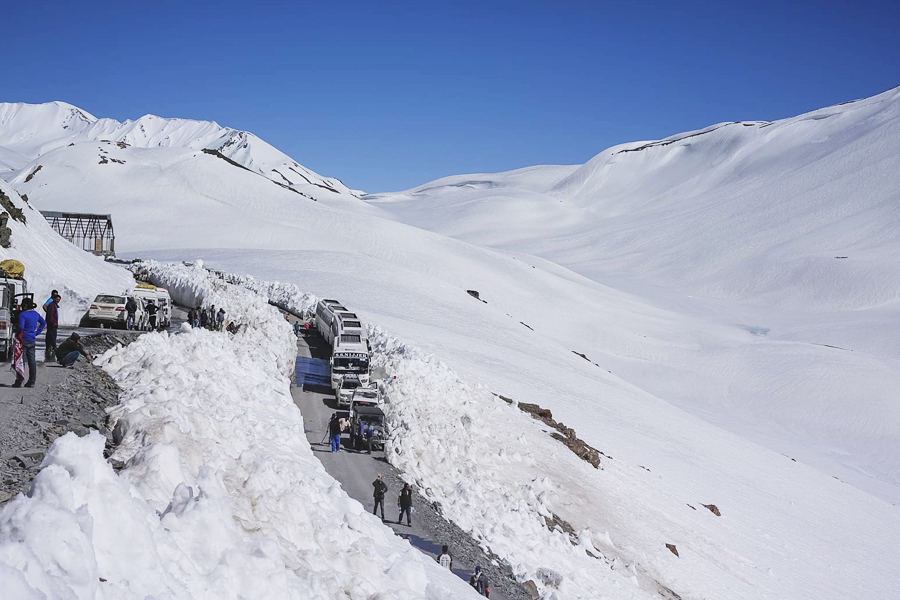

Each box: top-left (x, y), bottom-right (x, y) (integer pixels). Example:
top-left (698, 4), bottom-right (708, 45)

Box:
top-left (291, 326), bottom-right (531, 600)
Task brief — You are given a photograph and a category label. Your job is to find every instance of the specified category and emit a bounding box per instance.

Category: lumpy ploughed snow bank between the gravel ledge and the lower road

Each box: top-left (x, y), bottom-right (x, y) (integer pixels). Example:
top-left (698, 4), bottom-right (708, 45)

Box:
top-left (0, 264), bottom-right (474, 600)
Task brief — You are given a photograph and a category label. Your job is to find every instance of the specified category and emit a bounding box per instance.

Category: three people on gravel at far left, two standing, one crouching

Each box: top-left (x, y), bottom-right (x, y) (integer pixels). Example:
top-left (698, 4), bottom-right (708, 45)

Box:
top-left (12, 290), bottom-right (93, 388)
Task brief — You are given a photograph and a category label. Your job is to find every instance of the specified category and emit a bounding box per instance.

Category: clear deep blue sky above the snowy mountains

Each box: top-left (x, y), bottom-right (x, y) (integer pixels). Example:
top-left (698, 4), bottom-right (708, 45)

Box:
top-left (0, 0), bottom-right (900, 191)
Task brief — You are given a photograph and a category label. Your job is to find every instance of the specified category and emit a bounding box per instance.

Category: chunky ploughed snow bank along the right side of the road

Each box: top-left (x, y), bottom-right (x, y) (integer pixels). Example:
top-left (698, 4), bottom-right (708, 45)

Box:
top-left (212, 275), bottom-right (656, 599)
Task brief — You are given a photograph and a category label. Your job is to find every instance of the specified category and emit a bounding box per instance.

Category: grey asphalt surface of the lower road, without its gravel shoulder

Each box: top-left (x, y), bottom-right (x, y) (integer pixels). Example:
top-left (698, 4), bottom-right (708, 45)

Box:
top-left (291, 326), bottom-right (505, 600)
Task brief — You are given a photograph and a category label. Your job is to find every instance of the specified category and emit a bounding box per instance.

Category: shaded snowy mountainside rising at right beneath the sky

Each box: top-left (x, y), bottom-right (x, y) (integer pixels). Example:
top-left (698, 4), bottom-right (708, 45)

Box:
top-left (367, 88), bottom-right (900, 311)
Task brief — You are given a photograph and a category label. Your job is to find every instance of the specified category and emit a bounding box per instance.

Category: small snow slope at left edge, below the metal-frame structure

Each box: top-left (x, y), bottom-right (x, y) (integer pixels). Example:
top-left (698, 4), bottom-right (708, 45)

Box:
top-left (0, 179), bottom-right (134, 325)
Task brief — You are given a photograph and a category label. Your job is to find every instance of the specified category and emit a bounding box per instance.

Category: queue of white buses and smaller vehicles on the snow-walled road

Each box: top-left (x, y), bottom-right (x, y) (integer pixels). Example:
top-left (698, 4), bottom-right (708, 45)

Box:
top-left (313, 299), bottom-right (385, 452)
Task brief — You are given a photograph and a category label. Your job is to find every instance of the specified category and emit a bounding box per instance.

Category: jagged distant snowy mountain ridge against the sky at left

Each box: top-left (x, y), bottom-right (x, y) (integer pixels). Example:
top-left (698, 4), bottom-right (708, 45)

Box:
top-left (0, 102), bottom-right (354, 196)
